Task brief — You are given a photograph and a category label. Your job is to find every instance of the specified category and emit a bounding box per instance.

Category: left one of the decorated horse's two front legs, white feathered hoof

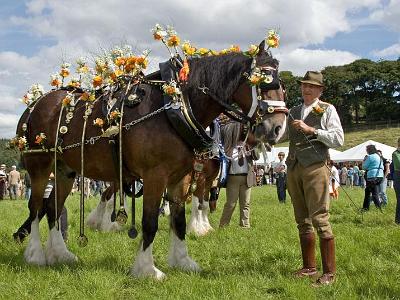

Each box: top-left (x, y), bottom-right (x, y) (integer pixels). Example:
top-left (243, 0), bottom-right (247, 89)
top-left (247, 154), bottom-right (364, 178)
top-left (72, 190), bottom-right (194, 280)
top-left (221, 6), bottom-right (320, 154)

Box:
top-left (130, 170), bottom-right (167, 280)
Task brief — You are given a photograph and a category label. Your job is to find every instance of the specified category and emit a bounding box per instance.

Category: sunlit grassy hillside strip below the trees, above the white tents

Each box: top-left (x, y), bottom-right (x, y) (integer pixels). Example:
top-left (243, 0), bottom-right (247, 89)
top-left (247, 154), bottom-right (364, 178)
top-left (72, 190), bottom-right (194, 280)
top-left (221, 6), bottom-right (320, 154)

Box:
top-left (276, 128), bottom-right (400, 151)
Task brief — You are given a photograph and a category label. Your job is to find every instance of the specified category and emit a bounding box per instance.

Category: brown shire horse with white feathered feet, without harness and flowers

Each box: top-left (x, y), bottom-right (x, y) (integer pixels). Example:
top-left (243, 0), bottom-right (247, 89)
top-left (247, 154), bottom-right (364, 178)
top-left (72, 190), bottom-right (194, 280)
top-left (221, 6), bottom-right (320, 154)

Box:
top-left (16, 41), bottom-right (287, 279)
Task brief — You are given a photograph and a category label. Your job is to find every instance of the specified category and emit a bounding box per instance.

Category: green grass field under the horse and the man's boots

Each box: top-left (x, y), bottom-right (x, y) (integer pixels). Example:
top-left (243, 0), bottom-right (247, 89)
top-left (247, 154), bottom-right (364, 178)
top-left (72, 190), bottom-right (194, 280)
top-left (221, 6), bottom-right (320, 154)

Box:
top-left (0, 186), bottom-right (400, 299)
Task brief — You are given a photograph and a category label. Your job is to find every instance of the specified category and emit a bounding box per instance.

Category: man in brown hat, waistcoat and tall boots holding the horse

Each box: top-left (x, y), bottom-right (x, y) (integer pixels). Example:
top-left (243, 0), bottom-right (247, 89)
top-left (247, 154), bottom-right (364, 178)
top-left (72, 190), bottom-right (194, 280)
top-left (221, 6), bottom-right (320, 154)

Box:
top-left (286, 71), bottom-right (344, 285)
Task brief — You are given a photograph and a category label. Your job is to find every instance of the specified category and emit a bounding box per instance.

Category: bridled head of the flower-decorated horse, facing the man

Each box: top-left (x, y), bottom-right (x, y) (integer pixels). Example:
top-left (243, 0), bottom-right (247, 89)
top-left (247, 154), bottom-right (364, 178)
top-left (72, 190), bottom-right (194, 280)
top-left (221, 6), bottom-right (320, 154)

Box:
top-left (233, 41), bottom-right (288, 145)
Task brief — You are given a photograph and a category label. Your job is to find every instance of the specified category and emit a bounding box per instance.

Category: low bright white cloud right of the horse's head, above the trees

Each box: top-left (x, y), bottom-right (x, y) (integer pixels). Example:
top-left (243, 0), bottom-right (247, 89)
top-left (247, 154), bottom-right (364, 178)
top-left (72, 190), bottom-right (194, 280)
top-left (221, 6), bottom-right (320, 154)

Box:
top-left (279, 49), bottom-right (360, 76)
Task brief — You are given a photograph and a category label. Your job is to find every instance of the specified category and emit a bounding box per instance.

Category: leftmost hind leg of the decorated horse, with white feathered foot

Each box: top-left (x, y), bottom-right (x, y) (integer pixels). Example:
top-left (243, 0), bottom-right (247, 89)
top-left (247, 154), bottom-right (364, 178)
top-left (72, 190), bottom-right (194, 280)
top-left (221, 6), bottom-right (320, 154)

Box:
top-left (24, 155), bottom-right (53, 266)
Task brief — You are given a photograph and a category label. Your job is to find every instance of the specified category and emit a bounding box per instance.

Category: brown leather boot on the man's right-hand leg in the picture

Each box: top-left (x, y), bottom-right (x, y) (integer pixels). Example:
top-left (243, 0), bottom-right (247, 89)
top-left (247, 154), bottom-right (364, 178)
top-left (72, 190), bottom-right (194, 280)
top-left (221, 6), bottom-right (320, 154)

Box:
top-left (315, 237), bottom-right (336, 286)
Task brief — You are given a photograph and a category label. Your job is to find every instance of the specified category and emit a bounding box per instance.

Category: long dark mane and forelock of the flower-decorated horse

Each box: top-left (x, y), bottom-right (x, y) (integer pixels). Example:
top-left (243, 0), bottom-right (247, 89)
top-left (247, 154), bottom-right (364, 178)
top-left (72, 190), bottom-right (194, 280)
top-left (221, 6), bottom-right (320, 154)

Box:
top-left (186, 53), bottom-right (279, 102)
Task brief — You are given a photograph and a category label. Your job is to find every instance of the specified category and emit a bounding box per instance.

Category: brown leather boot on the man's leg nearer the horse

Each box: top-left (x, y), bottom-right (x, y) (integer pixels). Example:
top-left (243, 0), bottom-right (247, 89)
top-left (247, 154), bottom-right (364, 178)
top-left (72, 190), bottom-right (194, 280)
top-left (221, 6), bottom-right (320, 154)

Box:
top-left (294, 232), bottom-right (317, 278)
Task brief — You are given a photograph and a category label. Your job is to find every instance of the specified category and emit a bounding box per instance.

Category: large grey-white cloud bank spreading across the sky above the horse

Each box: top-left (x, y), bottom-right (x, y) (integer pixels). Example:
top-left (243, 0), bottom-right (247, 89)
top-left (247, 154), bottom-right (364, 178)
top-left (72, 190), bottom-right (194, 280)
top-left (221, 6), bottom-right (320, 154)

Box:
top-left (0, 0), bottom-right (398, 137)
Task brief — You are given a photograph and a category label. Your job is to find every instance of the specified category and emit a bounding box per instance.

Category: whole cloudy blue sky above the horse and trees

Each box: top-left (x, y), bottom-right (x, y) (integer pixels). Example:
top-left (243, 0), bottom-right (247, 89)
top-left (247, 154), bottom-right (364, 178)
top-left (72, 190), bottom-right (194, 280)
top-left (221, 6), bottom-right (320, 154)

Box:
top-left (0, 0), bottom-right (400, 138)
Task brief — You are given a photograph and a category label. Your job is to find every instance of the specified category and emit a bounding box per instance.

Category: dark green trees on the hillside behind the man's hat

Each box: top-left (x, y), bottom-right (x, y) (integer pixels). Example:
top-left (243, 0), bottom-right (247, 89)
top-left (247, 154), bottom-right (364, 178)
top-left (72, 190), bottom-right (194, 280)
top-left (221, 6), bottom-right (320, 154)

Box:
top-left (280, 58), bottom-right (400, 127)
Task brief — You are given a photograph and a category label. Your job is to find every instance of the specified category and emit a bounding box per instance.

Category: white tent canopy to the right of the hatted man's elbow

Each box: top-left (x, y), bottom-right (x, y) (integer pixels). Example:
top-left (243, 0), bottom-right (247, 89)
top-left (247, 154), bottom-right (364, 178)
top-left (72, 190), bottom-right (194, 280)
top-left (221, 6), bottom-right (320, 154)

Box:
top-left (331, 140), bottom-right (396, 162)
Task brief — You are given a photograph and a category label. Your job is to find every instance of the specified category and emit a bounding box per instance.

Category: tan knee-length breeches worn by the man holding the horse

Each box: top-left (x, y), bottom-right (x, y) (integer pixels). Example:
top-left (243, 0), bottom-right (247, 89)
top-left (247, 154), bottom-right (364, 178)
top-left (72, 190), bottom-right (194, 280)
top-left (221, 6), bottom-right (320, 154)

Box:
top-left (287, 162), bottom-right (333, 239)
